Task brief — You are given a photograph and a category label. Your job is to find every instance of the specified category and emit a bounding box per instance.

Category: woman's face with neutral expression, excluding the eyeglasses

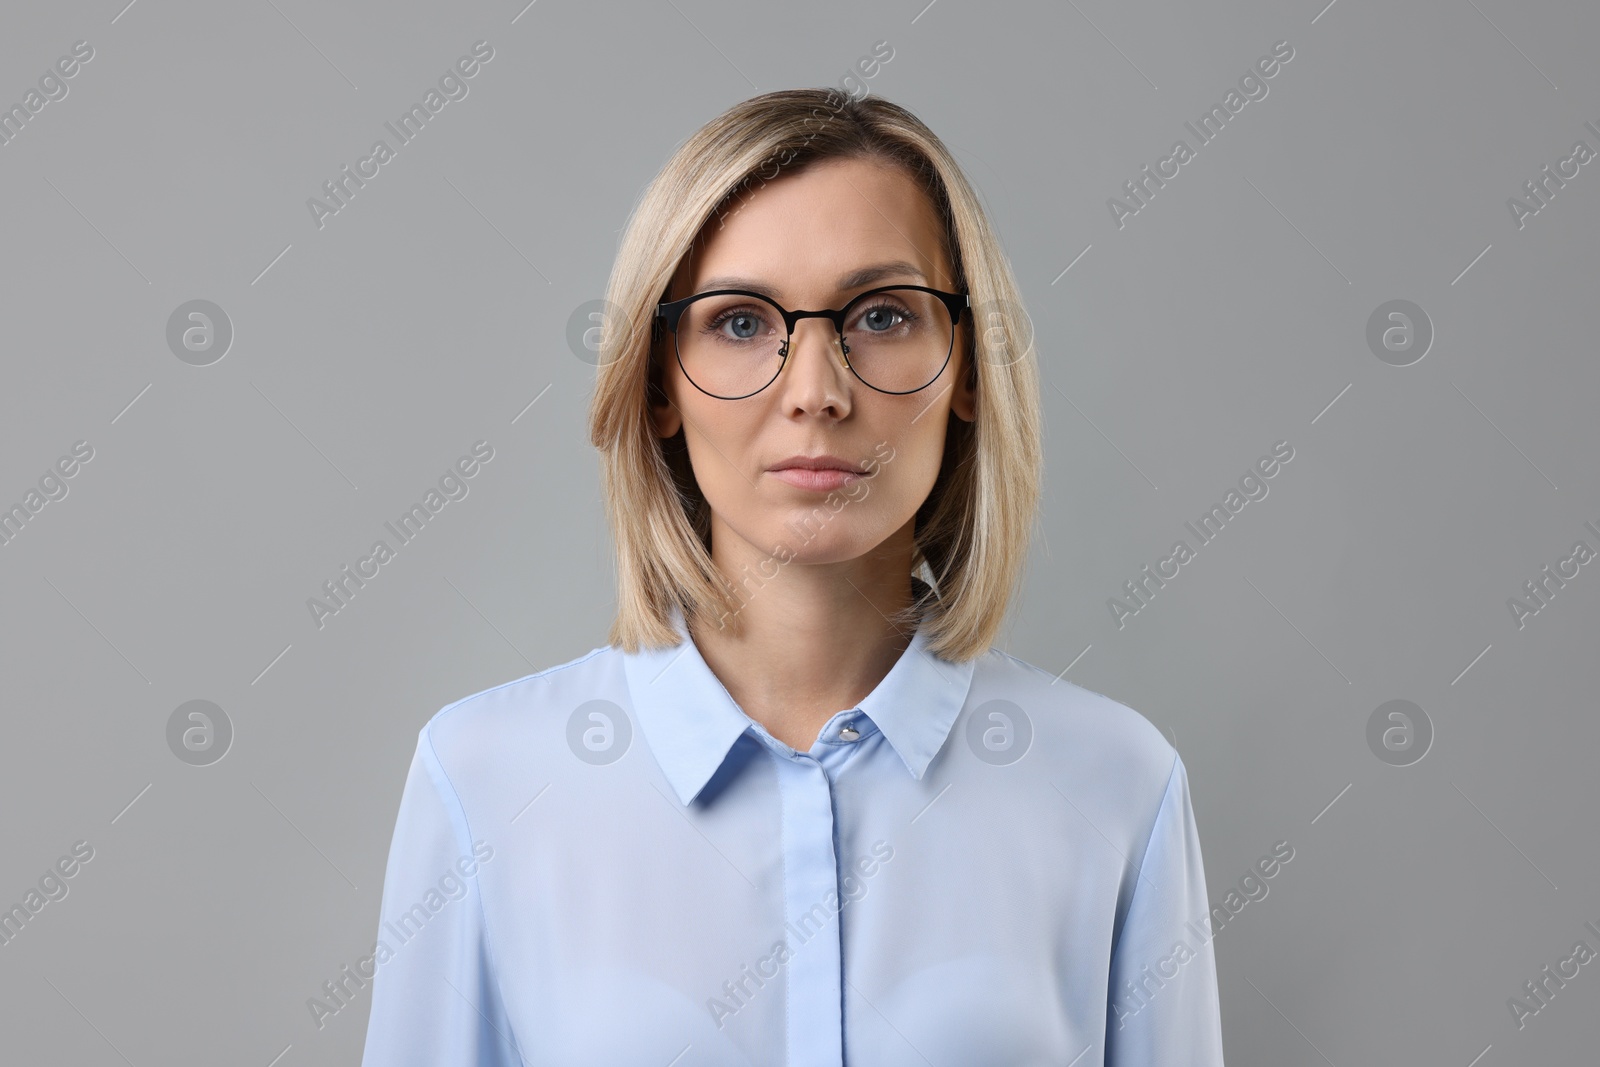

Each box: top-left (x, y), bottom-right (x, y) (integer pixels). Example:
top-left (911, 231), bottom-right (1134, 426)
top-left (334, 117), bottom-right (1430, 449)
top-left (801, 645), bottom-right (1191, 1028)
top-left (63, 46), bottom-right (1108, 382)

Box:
top-left (653, 160), bottom-right (974, 577)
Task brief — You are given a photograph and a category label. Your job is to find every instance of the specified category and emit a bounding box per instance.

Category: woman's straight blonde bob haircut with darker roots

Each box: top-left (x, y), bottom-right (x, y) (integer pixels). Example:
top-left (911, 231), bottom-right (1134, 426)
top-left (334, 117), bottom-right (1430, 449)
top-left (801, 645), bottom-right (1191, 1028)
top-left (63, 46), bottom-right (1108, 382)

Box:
top-left (589, 88), bottom-right (1042, 662)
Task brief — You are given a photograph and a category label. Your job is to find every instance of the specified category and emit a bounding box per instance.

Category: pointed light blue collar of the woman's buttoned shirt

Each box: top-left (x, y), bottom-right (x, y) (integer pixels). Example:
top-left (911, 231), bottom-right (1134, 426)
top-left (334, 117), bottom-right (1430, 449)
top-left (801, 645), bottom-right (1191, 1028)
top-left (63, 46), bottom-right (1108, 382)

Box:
top-left (622, 606), bottom-right (976, 805)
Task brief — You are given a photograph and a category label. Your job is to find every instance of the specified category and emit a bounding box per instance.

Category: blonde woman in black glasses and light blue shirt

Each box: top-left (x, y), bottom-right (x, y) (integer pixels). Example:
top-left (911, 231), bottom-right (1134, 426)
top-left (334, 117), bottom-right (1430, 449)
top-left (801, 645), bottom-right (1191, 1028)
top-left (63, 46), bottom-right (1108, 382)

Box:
top-left (362, 90), bottom-right (1222, 1067)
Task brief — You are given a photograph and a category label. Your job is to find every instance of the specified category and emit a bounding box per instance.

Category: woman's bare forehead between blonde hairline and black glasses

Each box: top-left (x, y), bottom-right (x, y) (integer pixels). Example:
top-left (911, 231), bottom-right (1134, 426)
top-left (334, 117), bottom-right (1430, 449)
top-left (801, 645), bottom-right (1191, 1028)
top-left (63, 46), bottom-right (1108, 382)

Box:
top-left (672, 160), bottom-right (952, 307)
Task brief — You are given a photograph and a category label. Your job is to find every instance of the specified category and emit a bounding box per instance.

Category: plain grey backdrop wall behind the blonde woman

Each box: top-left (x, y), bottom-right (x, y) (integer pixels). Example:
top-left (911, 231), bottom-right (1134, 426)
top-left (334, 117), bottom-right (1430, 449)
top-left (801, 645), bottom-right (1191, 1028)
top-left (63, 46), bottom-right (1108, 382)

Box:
top-left (0, 0), bottom-right (1600, 1067)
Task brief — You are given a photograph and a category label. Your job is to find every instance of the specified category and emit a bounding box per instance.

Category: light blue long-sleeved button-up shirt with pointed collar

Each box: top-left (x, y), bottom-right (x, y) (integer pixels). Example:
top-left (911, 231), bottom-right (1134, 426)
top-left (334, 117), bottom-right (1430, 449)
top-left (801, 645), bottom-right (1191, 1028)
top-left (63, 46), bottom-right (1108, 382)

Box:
top-left (350, 601), bottom-right (1222, 1067)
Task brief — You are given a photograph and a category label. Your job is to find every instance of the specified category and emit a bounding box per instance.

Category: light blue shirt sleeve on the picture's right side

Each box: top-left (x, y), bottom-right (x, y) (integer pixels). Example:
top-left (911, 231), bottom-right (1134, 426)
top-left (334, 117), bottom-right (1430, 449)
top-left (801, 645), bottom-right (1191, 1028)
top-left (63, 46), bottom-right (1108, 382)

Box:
top-left (1106, 757), bottom-right (1222, 1067)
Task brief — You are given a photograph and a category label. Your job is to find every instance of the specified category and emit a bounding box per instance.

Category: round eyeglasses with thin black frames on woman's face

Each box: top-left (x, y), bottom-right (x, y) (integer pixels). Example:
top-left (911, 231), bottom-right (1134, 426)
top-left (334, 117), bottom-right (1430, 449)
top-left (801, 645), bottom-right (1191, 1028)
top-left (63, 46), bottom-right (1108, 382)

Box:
top-left (656, 285), bottom-right (973, 400)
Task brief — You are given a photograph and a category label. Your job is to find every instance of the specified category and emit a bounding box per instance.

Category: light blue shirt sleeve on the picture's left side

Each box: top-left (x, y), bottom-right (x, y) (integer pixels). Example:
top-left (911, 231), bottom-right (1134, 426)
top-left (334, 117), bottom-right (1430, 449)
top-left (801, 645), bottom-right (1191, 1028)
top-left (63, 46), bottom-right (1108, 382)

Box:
top-left (362, 726), bottom-right (522, 1067)
